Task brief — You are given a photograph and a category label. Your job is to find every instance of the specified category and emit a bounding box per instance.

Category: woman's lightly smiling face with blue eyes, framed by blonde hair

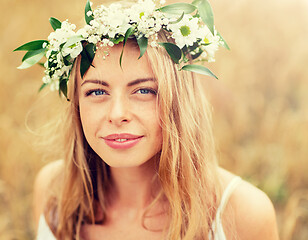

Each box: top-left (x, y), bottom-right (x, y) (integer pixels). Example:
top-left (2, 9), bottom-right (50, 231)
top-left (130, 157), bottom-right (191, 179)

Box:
top-left (77, 42), bottom-right (162, 167)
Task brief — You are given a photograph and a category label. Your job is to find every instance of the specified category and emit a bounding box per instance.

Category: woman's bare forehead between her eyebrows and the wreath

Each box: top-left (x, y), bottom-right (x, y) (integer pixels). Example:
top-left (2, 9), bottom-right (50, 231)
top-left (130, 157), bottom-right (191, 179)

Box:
top-left (78, 41), bottom-right (154, 86)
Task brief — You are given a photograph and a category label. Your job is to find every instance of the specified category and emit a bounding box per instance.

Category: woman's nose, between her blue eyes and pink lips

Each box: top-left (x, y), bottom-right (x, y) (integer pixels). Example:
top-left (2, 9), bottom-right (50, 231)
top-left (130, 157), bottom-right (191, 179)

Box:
top-left (108, 96), bottom-right (131, 126)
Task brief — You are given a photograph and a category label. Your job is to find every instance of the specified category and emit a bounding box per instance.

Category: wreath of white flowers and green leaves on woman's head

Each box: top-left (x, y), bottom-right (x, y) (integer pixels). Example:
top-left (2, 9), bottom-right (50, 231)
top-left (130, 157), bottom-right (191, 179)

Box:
top-left (14, 0), bottom-right (229, 97)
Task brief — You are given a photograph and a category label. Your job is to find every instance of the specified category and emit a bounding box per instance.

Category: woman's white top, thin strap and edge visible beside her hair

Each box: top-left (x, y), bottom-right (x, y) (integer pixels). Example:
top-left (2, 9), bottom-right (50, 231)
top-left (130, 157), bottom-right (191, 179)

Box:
top-left (36, 176), bottom-right (242, 240)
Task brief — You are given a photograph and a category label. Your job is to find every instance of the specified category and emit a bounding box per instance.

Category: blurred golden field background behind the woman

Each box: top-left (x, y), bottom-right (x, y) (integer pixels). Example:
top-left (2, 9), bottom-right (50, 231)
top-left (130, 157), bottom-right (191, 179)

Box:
top-left (0, 0), bottom-right (308, 240)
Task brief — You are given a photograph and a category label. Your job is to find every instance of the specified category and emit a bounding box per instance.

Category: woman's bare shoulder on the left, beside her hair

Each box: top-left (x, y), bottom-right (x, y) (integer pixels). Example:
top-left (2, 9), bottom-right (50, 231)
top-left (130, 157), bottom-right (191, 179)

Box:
top-left (33, 160), bottom-right (64, 229)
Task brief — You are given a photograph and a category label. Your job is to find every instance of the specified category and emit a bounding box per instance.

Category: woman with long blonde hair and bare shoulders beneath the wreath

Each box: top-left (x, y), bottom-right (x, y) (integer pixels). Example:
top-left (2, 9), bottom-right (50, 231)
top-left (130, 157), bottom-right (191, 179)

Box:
top-left (17, 0), bottom-right (278, 240)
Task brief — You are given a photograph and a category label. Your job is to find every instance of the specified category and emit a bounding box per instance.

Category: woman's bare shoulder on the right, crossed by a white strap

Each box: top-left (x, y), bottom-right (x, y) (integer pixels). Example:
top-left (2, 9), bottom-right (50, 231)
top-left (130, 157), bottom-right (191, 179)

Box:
top-left (219, 169), bottom-right (279, 240)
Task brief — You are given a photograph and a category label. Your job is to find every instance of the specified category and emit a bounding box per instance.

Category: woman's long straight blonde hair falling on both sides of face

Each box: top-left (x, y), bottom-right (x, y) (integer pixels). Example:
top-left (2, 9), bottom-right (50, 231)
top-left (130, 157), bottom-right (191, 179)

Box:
top-left (45, 30), bottom-right (220, 240)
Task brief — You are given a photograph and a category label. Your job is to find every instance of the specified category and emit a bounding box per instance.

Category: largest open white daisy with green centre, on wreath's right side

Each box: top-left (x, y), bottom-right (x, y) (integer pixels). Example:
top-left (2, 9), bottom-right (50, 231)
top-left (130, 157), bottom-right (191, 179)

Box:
top-left (168, 15), bottom-right (200, 48)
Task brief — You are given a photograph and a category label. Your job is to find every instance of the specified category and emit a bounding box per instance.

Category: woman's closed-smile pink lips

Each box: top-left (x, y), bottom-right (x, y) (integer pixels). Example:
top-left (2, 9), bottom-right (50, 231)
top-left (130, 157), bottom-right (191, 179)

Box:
top-left (103, 133), bottom-right (143, 149)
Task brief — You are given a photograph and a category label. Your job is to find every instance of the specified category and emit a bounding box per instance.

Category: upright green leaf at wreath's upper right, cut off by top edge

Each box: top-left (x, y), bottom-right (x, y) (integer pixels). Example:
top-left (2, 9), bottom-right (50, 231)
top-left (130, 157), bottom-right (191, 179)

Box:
top-left (192, 0), bottom-right (214, 35)
